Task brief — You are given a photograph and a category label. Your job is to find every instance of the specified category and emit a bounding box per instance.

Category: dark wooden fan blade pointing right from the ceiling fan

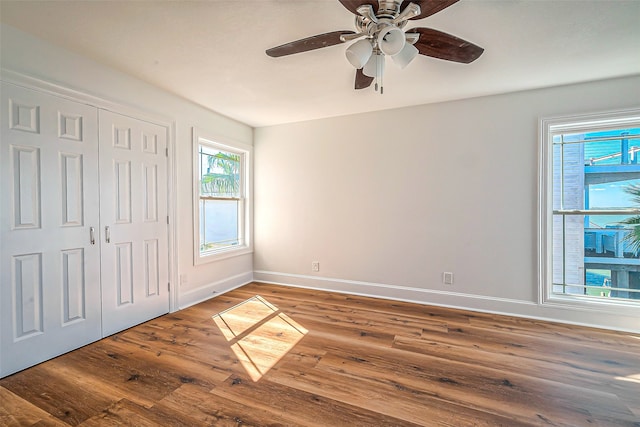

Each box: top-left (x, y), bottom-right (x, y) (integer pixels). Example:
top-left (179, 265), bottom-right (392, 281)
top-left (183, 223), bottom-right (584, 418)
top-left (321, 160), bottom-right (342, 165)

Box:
top-left (407, 28), bottom-right (484, 64)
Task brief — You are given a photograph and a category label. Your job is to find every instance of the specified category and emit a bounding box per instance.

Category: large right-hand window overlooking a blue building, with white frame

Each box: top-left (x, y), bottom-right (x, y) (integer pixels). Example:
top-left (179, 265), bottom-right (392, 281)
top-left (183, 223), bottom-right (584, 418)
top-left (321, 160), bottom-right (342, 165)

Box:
top-left (540, 111), bottom-right (640, 309)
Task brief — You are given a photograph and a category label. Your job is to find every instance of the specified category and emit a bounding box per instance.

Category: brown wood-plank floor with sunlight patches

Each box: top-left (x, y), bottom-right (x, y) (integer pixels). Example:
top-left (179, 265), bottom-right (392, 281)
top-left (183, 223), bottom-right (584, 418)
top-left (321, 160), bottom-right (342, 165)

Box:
top-left (0, 283), bottom-right (640, 427)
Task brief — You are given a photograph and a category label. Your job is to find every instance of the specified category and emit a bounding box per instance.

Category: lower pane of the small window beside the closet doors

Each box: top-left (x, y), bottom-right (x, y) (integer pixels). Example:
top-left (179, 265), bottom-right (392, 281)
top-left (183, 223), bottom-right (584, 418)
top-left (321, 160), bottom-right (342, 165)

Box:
top-left (200, 200), bottom-right (240, 252)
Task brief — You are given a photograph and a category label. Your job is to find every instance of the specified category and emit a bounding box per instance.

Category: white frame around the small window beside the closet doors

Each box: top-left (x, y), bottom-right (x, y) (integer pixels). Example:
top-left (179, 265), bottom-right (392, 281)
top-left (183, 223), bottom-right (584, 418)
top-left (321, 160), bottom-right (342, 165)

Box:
top-left (192, 127), bottom-right (253, 265)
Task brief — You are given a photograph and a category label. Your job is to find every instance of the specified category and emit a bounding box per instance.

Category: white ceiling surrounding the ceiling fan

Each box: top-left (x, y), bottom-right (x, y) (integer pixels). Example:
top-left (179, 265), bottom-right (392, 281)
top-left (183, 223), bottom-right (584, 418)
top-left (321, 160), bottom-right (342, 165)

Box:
top-left (0, 0), bottom-right (640, 127)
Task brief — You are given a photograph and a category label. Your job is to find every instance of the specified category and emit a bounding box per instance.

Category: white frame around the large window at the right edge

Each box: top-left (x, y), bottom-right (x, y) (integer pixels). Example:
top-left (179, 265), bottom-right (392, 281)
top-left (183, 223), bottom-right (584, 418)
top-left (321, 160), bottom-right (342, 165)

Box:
top-left (538, 109), bottom-right (640, 314)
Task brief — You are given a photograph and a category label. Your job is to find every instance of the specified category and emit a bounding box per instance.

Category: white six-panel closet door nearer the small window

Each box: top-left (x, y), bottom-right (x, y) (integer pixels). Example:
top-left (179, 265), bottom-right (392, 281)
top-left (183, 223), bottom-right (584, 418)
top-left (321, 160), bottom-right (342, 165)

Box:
top-left (99, 110), bottom-right (169, 336)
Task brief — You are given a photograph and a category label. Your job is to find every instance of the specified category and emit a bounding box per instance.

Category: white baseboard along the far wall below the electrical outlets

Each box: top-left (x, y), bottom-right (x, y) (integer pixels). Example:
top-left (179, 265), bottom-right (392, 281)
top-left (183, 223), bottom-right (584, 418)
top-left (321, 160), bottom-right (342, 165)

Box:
top-left (253, 270), bottom-right (640, 333)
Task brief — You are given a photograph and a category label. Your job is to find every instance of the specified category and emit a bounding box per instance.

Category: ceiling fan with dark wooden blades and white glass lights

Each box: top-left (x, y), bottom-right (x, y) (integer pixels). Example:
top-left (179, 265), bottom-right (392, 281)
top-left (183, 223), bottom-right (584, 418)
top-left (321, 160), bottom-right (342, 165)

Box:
top-left (266, 0), bottom-right (484, 93)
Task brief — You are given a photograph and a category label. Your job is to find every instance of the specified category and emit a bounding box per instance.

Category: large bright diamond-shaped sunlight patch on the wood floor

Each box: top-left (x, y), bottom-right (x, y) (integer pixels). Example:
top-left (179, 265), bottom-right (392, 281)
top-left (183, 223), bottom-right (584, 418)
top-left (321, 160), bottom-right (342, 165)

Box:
top-left (212, 295), bottom-right (308, 381)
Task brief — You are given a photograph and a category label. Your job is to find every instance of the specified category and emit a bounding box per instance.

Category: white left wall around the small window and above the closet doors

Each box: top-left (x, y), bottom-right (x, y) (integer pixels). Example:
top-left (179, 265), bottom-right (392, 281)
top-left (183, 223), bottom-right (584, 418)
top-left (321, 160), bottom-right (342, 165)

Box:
top-left (0, 25), bottom-right (253, 307)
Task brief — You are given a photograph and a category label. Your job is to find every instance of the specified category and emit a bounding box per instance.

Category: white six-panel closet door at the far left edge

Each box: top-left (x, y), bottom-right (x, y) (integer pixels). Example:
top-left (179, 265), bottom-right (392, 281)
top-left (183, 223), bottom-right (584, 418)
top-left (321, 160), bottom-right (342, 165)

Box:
top-left (0, 83), bottom-right (101, 376)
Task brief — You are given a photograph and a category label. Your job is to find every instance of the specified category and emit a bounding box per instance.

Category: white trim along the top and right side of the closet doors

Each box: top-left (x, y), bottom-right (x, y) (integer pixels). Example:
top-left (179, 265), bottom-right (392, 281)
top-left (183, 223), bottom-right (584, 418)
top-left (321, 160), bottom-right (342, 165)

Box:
top-left (0, 68), bottom-right (179, 313)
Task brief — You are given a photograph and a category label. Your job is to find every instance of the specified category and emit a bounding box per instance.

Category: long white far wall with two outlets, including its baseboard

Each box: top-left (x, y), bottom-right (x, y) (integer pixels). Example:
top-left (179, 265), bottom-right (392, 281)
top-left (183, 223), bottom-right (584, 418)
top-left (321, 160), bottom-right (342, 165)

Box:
top-left (254, 76), bottom-right (640, 331)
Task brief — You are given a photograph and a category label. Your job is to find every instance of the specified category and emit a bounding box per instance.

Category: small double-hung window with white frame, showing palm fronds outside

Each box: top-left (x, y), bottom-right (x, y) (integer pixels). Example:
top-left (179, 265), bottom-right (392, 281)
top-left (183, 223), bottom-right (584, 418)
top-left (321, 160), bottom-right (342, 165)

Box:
top-left (193, 129), bottom-right (251, 264)
